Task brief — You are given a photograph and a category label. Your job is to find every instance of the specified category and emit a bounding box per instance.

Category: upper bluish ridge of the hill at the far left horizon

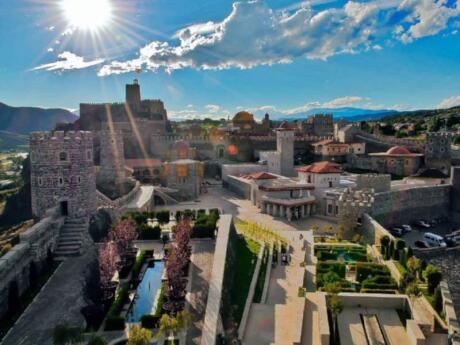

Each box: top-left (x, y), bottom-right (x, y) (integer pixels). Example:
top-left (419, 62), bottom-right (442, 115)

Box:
top-left (0, 102), bottom-right (78, 135)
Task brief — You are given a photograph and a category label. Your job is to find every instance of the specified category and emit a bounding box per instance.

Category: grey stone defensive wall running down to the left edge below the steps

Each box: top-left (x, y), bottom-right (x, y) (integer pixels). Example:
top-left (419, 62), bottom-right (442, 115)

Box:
top-left (0, 207), bottom-right (65, 317)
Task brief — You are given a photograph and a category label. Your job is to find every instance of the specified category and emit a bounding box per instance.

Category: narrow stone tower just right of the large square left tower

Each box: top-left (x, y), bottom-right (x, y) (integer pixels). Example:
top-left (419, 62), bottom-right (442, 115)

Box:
top-left (98, 123), bottom-right (125, 185)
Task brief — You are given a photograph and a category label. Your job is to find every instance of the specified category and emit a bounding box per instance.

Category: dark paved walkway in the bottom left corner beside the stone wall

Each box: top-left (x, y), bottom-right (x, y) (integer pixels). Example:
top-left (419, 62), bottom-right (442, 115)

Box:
top-left (2, 239), bottom-right (95, 345)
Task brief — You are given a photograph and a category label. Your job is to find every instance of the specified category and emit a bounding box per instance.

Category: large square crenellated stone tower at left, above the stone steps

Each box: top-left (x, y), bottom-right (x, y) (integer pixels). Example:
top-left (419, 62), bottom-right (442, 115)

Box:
top-left (30, 131), bottom-right (96, 218)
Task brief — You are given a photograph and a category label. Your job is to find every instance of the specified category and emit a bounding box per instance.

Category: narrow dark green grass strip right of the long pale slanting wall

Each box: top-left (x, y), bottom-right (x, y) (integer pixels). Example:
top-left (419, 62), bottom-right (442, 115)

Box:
top-left (231, 237), bottom-right (260, 324)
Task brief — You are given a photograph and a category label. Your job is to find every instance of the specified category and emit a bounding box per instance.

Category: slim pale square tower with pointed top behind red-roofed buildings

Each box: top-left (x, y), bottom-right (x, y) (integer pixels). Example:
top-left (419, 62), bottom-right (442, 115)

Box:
top-left (276, 121), bottom-right (295, 176)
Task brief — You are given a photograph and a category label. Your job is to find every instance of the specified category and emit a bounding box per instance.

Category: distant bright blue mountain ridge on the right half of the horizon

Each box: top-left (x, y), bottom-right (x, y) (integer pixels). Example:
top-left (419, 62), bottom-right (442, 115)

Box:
top-left (250, 107), bottom-right (398, 121)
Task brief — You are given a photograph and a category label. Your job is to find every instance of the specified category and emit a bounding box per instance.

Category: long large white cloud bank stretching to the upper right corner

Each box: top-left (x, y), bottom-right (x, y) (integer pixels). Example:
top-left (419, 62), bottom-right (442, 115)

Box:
top-left (98, 0), bottom-right (460, 76)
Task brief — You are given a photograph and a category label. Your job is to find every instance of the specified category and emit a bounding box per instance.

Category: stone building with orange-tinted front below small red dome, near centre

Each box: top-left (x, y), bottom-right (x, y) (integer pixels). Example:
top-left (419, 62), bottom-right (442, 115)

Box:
top-left (162, 159), bottom-right (204, 200)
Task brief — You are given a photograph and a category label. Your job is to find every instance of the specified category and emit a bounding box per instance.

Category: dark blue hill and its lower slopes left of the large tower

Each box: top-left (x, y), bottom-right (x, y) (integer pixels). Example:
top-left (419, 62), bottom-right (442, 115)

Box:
top-left (0, 102), bottom-right (78, 151)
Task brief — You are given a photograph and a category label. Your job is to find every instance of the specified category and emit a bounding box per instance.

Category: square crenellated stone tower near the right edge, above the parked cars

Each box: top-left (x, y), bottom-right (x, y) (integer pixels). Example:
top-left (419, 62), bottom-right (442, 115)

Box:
top-left (425, 132), bottom-right (452, 175)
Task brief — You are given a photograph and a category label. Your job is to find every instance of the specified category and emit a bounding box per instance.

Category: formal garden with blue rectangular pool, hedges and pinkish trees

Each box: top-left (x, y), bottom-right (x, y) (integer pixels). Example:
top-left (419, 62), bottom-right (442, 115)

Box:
top-left (64, 210), bottom-right (207, 344)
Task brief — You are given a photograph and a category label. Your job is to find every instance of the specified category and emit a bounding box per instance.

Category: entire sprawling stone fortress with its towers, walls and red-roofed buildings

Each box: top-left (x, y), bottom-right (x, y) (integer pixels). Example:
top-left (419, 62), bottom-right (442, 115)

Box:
top-left (0, 81), bottom-right (460, 344)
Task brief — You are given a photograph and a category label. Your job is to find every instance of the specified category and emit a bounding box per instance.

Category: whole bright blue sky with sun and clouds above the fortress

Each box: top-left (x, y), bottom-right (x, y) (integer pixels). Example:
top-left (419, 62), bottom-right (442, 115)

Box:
top-left (0, 0), bottom-right (460, 118)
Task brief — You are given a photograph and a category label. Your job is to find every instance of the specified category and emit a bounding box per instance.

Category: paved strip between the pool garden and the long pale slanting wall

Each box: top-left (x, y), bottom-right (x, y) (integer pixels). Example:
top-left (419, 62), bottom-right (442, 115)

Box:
top-left (186, 240), bottom-right (215, 345)
